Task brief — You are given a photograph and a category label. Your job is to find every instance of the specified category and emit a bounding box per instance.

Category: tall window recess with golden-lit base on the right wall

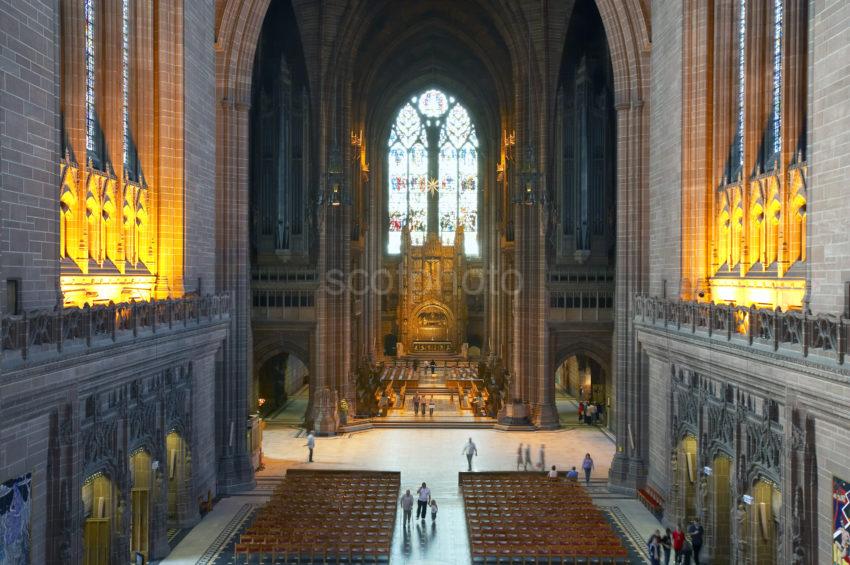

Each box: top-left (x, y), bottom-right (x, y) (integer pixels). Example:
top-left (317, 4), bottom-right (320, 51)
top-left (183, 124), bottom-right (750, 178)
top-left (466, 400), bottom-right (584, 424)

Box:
top-left (684, 0), bottom-right (808, 310)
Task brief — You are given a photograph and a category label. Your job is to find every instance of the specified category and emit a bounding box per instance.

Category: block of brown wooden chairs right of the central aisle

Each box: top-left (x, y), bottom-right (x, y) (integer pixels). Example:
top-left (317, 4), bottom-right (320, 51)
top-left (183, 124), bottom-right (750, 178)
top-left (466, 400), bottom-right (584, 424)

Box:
top-left (460, 473), bottom-right (629, 565)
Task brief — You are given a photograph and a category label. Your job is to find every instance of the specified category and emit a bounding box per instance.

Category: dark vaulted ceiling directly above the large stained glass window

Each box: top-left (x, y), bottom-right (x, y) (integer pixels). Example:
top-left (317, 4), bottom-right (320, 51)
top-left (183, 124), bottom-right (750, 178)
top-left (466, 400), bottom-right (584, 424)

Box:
top-left (342, 0), bottom-right (516, 140)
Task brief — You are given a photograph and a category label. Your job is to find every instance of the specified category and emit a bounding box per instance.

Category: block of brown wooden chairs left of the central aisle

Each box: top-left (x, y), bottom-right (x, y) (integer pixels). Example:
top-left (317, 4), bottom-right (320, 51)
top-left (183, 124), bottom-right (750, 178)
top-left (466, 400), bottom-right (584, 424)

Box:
top-left (234, 469), bottom-right (400, 564)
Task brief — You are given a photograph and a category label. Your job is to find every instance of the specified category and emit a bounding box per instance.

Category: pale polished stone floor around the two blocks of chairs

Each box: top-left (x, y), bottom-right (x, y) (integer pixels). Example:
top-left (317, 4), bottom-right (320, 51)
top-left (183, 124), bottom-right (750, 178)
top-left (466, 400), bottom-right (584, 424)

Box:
top-left (163, 426), bottom-right (659, 565)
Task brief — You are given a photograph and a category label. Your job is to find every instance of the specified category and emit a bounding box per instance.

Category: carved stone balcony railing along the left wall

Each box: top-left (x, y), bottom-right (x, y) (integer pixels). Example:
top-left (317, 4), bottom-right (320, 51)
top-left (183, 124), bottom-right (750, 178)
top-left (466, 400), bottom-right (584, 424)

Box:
top-left (0, 294), bottom-right (230, 362)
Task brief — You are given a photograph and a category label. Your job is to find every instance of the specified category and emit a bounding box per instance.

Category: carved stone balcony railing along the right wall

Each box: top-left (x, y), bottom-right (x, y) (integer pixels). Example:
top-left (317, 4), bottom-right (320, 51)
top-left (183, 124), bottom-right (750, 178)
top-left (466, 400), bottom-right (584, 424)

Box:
top-left (635, 295), bottom-right (850, 365)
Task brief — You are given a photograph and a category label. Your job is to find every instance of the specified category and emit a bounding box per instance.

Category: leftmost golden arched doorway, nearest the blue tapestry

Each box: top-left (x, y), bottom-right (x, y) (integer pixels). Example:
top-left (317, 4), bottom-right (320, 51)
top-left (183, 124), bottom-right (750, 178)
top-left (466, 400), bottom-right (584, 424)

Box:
top-left (82, 473), bottom-right (117, 565)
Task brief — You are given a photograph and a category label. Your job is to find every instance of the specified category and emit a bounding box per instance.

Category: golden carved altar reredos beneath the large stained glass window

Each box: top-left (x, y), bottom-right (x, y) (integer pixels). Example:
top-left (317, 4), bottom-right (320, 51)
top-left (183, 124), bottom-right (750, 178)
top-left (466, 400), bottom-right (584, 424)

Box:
top-left (398, 227), bottom-right (466, 353)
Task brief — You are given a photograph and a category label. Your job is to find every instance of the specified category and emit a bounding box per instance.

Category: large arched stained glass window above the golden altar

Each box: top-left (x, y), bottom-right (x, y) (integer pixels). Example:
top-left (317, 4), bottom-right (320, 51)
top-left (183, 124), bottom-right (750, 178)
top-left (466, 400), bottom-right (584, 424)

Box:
top-left (387, 89), bottom-right (479, 255)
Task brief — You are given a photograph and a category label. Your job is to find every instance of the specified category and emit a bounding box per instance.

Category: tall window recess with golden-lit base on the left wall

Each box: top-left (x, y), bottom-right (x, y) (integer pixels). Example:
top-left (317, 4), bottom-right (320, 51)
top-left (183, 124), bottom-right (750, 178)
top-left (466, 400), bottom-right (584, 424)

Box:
top-left (59, 0), bottom-right (183, 307)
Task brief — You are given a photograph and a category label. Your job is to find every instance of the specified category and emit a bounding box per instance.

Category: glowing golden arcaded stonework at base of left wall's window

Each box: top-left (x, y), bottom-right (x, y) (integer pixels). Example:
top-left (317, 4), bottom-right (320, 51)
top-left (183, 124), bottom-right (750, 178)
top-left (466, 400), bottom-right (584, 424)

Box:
top-left (59, 159), bottom-right (182, 308)
